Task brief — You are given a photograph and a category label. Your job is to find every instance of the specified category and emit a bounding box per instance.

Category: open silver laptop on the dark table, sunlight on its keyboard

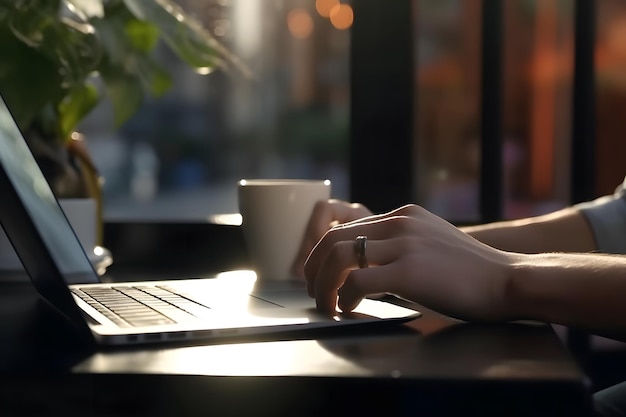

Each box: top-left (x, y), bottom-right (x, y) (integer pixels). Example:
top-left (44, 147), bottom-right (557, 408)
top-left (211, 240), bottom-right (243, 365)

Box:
top-left (0, 97), bottom-right (420, 345)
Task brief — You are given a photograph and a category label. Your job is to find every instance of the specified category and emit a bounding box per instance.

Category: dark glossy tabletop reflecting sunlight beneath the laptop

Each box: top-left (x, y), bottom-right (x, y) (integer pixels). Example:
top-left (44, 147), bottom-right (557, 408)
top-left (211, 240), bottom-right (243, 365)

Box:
top-left (0, 274), bottom-right (590, 415)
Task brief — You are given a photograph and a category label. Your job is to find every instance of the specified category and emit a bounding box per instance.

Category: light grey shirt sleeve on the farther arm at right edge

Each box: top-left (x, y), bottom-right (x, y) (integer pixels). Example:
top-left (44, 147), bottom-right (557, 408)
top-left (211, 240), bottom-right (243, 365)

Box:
top-left (574, 178), bottom-right (626, 254)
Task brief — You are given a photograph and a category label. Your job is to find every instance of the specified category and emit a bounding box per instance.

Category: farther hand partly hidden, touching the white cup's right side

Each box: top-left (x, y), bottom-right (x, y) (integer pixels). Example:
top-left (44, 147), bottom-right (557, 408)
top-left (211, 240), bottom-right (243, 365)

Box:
top-left (293, 200), bottom-right (372, 277)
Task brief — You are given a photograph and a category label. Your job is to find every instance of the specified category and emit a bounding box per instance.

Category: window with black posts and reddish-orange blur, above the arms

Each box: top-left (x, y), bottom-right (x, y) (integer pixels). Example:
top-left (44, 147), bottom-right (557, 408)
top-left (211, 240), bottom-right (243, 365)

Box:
top-left (352, 0), bottom-right (626, 223)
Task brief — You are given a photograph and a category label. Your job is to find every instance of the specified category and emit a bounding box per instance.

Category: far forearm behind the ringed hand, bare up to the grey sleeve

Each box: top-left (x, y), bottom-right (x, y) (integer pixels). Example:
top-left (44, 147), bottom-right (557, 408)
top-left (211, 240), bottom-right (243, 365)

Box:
top-left (461, 208), bottom-right (596, 253)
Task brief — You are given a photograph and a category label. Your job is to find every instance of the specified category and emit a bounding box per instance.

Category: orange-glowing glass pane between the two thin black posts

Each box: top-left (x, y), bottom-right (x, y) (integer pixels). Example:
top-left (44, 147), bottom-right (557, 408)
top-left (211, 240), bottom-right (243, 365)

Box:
top-left (503, 0), bottom-right (574, 218)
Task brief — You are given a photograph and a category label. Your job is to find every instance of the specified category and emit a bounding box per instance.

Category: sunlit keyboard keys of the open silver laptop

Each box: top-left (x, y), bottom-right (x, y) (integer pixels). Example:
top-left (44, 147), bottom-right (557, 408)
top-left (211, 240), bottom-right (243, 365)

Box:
top-left (72, 285), bottom-right (211, 327)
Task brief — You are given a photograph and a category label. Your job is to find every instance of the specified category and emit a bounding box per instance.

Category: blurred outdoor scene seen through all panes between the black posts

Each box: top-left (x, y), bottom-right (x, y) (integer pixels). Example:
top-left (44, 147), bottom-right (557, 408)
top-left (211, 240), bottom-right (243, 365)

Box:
top-left (80, 0), bottom-right (626, 222)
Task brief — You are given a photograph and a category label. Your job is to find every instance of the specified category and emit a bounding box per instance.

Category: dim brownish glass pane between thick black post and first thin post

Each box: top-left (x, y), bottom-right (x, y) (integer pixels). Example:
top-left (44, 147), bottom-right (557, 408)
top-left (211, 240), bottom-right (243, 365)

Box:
top-left (415, 0), bottom-right (481, 221)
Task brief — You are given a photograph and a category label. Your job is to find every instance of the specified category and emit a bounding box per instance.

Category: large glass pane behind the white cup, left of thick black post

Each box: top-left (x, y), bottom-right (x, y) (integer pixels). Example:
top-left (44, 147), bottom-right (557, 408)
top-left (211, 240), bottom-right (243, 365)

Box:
top-left (82, 0), bottom-right (352, 220)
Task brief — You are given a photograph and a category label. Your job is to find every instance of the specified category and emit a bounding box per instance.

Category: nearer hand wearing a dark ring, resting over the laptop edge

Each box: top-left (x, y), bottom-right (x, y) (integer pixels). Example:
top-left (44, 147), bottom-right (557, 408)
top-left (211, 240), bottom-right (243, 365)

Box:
top-left (305, 205), bottom-right (516, 320)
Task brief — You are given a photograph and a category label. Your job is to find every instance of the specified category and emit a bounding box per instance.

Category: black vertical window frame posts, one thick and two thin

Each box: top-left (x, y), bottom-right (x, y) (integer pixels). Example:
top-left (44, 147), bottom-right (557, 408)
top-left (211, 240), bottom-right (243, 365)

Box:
top-left (350, 0), bottom-right (596, 223)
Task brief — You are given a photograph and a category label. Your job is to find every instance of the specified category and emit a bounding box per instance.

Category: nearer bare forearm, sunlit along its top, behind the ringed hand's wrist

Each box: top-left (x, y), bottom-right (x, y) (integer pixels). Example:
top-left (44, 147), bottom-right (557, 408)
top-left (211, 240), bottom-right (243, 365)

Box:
top-left (503, 254), bottom-right (626, 340)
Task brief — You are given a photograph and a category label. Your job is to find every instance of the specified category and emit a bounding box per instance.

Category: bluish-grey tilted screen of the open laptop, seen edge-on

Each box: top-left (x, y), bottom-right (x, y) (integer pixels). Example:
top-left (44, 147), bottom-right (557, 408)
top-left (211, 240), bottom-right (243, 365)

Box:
top-left (0, 98), bottom-right (94, 277)
